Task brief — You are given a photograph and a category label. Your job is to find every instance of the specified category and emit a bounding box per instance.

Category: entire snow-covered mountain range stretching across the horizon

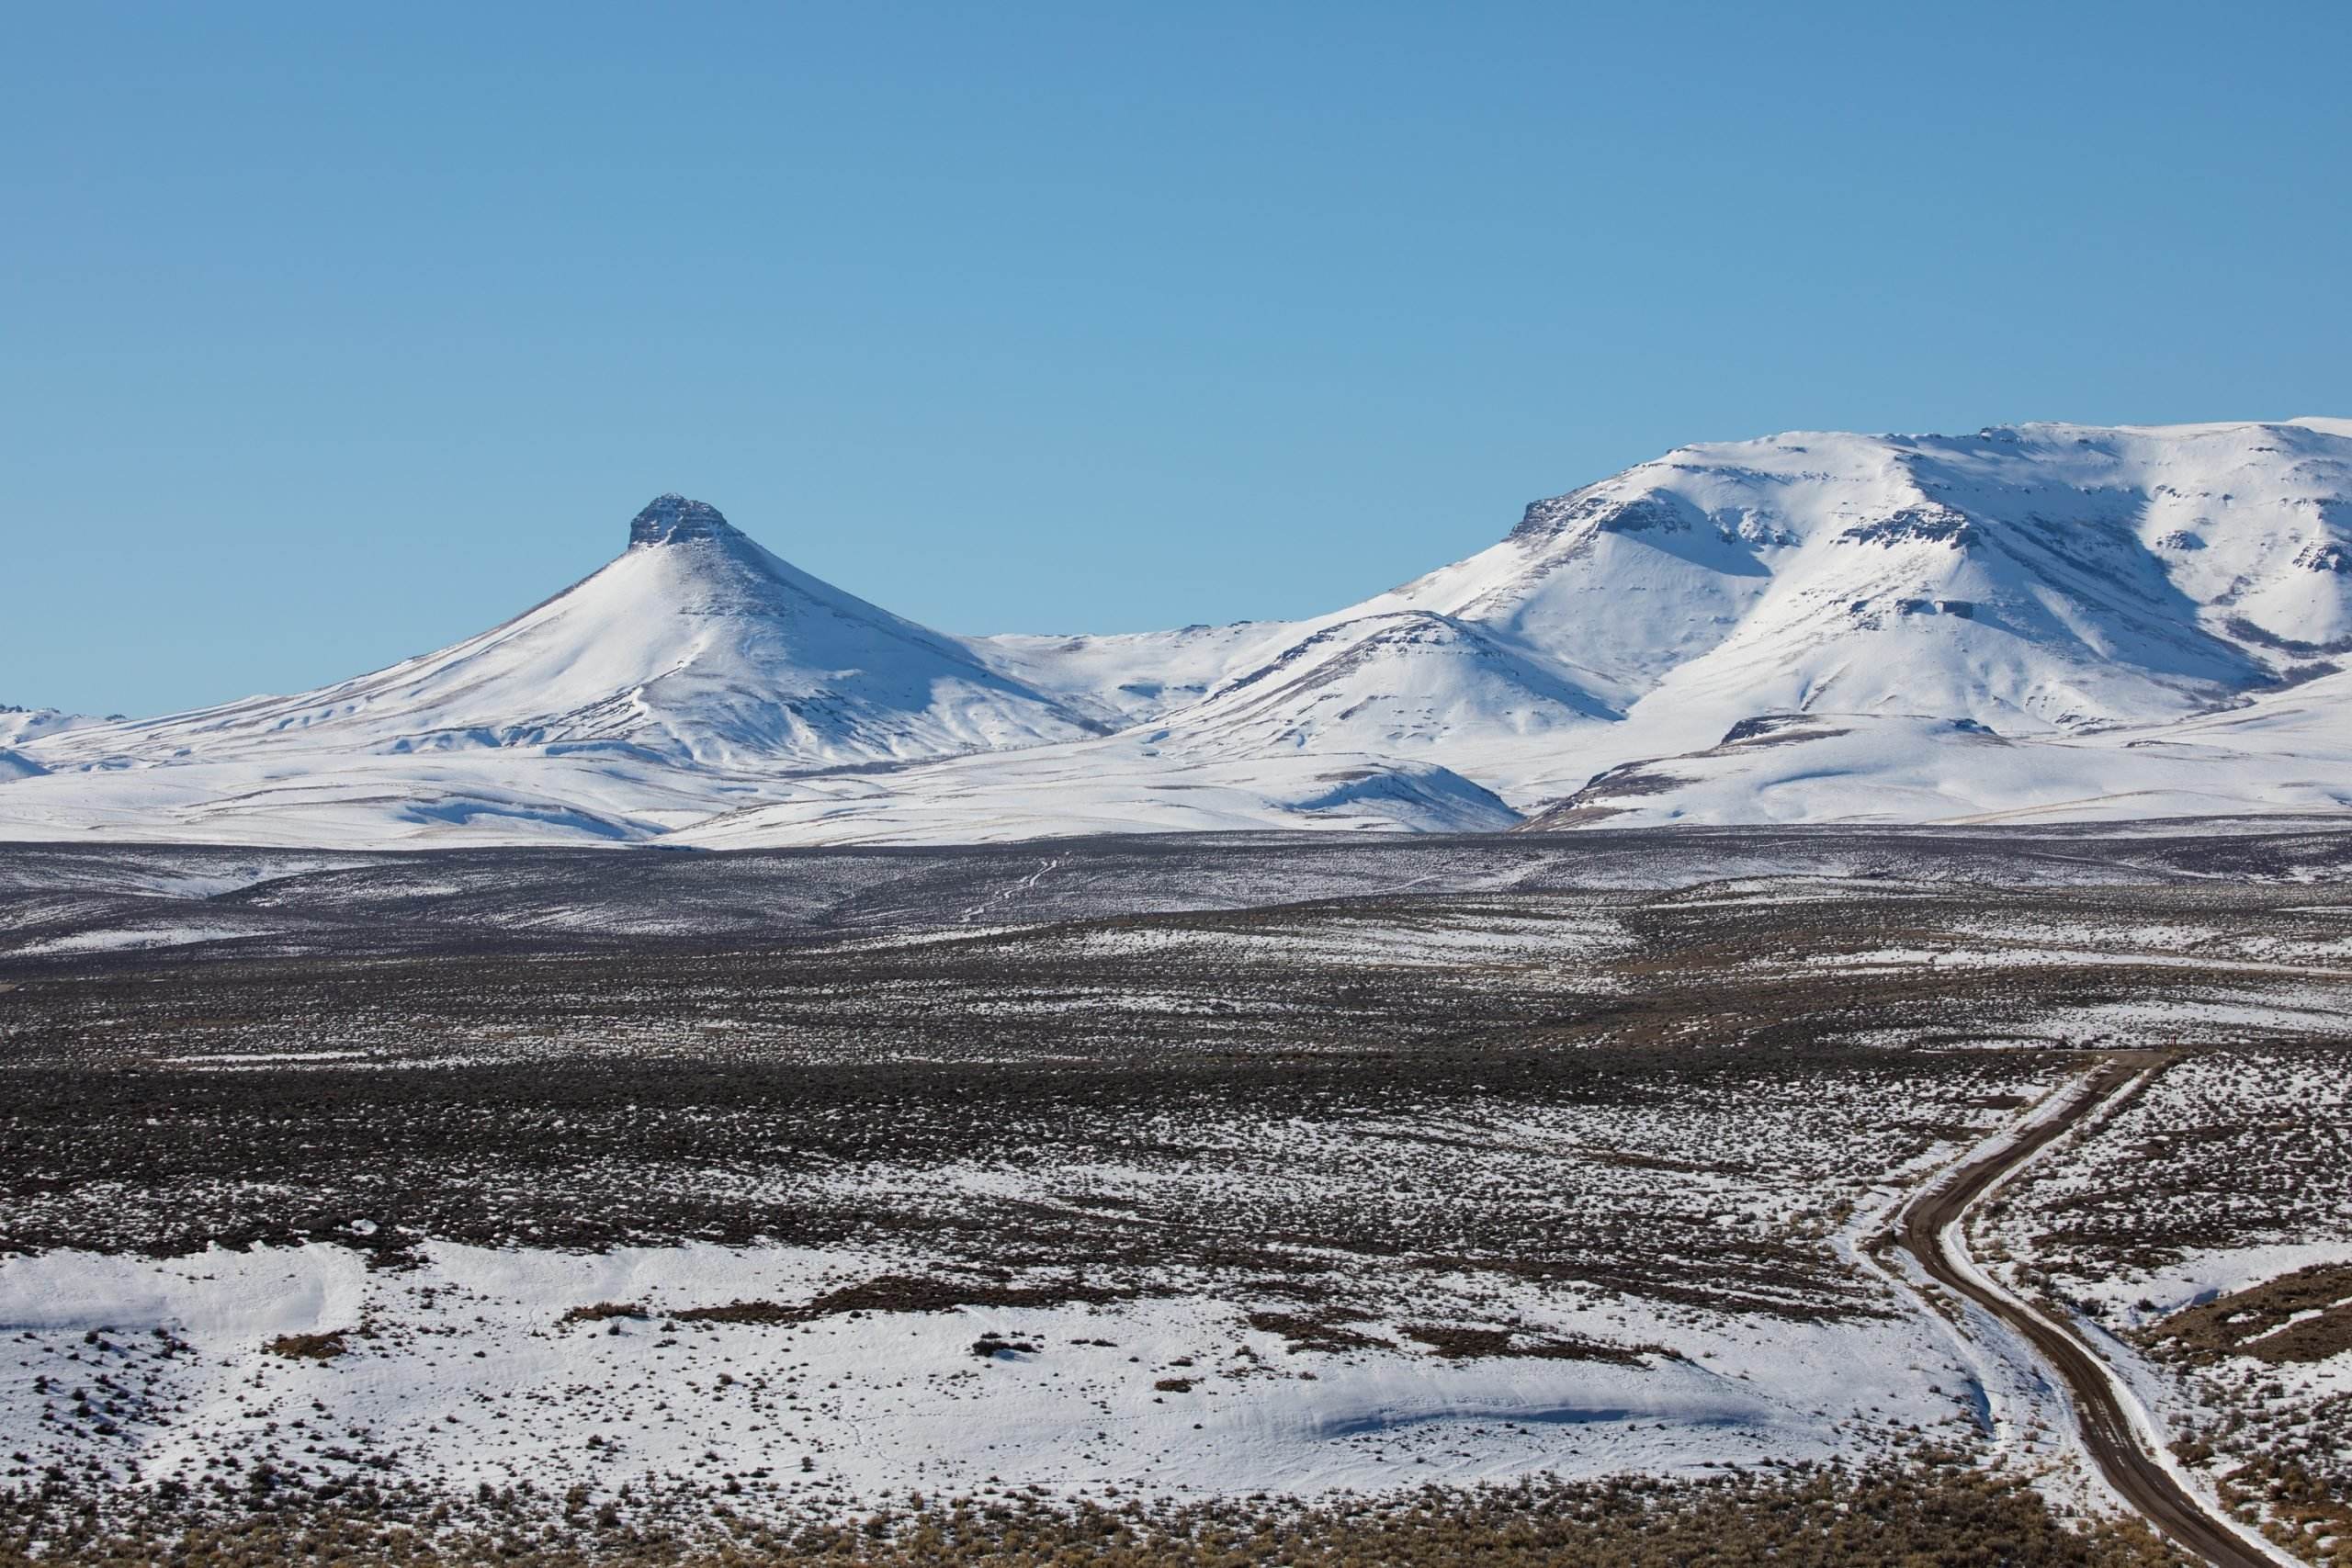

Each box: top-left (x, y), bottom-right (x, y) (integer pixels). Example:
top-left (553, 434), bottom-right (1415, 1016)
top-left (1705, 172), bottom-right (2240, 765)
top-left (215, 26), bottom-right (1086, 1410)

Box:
top-left (0, 419), bottom-right (2352, 844)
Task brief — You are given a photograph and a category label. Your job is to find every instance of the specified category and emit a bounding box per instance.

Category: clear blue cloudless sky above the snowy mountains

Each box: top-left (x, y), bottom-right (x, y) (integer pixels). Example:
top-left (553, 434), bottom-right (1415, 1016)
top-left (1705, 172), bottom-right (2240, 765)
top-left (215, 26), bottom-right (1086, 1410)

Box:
top-left (0, 0), bottom-right (2352, 712)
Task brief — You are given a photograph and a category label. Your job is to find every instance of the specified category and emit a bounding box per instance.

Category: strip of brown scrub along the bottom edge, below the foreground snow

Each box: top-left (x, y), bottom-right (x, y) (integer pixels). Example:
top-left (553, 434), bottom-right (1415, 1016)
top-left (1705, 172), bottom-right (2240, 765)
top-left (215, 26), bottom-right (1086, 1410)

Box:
top-left (0, 1470), bottom-right (2185, 1568)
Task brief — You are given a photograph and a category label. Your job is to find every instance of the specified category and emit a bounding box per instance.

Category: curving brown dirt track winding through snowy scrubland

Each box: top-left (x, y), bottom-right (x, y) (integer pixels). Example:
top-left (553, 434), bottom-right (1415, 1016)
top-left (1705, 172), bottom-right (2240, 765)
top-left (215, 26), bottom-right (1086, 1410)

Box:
top-left (1895, 1055), bottom-right (2281, 1568)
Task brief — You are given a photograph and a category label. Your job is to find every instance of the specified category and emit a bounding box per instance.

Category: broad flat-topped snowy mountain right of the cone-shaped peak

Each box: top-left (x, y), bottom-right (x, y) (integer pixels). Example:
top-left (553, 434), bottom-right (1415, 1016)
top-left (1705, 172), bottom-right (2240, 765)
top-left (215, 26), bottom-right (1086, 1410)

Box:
top-left (1124, 421), bottom-right (2352, 804)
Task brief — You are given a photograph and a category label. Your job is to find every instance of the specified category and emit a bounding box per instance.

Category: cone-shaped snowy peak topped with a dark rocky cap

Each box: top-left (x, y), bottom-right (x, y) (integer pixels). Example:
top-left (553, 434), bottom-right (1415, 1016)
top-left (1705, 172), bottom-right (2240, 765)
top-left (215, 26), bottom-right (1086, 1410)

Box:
top-left (28, 496), bottom-right (1101, 769)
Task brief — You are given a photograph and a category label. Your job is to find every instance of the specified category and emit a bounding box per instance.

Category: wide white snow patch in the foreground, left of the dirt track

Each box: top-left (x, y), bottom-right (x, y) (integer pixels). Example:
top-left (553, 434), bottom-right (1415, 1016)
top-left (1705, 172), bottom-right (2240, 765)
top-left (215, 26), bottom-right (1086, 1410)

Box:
top-left (0, 1244), bottom-right (1971, 1509)
